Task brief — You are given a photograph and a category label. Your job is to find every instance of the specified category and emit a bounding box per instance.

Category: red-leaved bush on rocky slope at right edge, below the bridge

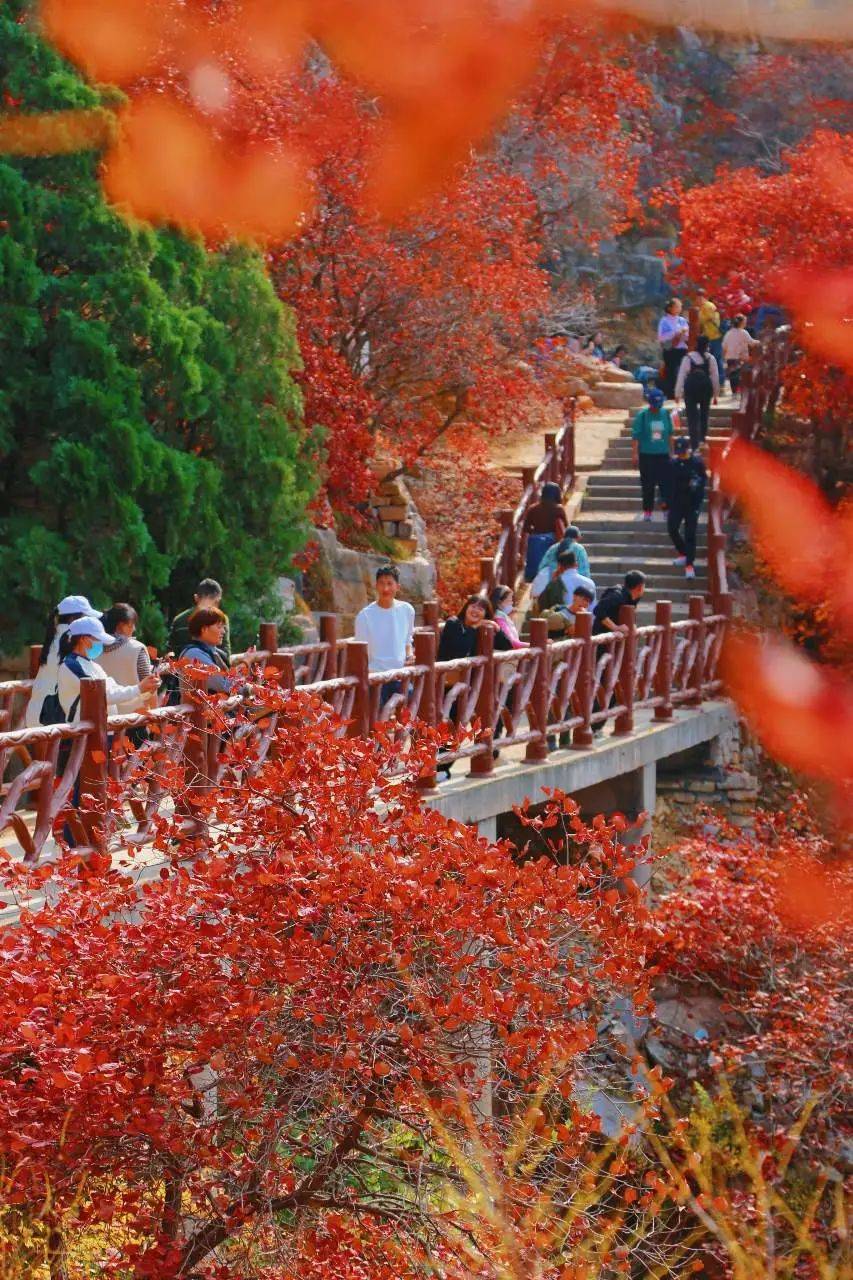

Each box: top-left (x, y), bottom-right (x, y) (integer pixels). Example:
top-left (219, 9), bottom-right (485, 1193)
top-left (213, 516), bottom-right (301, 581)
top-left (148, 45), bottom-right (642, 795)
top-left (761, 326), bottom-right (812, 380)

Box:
top-left (656, 801), bottom-right (853, 1164)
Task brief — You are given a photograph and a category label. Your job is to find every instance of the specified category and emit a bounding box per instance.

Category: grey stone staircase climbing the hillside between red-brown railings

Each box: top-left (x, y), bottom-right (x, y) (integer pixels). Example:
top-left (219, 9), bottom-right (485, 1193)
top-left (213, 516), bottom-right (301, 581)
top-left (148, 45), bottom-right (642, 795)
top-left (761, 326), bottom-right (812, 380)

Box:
top-left (576, 404), bottom-right (734, 625)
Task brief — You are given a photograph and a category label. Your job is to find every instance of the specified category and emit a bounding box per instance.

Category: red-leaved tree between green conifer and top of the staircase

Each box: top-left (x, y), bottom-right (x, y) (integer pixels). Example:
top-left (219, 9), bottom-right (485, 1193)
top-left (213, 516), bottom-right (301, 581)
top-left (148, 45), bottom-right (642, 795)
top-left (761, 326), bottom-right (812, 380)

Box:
top-left (263, 23), bottom-right (644, 511)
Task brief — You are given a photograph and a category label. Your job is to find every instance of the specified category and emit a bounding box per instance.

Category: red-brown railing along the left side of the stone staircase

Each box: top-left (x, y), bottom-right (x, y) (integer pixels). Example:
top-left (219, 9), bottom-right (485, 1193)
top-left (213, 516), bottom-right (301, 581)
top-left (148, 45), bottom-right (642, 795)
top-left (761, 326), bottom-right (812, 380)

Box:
top-left (480, 397), bottom-right (578, 595)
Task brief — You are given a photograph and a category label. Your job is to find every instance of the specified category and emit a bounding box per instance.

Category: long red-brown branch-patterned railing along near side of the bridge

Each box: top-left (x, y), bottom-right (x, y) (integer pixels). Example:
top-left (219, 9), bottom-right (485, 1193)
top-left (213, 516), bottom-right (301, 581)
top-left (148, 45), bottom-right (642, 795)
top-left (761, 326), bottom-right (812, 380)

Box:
top-left (0, 595), bottom-right (731, 863)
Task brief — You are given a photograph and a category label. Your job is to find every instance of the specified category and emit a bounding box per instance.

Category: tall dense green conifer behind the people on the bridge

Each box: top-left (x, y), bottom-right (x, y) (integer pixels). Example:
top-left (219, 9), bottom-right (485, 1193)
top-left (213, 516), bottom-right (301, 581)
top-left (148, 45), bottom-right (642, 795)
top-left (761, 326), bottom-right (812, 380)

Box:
top-left (0, 3), bottom-right (315, 653)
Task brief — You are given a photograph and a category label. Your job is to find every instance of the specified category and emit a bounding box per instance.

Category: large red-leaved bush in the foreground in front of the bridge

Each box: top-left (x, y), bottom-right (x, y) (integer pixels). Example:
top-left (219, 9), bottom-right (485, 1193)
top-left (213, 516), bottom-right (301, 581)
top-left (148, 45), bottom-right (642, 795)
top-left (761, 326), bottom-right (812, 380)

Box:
top-left (0, 690), bottom-right (648, 1277)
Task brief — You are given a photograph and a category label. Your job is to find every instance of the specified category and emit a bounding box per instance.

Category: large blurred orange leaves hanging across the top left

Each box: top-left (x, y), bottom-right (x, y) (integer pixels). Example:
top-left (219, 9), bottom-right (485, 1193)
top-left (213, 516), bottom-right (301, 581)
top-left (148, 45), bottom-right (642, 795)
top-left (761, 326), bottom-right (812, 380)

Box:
top-left (41, 0), bottom-right (544, 241)
